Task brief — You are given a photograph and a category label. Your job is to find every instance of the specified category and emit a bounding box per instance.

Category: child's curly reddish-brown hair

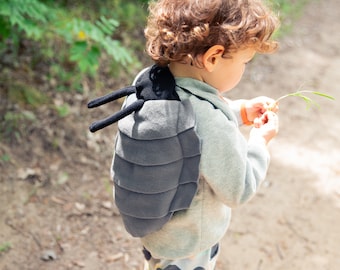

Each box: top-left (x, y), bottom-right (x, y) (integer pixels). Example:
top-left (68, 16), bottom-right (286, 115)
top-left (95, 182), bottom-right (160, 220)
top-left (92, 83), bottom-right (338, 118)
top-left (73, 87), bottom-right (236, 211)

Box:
top-left (145, 0), bottom-right (279, 66)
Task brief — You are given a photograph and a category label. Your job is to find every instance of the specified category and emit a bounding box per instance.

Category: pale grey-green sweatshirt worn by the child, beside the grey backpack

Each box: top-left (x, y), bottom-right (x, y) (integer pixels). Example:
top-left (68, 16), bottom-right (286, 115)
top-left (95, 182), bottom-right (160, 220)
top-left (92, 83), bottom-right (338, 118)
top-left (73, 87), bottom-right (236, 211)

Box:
top-left (141, 78), bottom-right (270, 260)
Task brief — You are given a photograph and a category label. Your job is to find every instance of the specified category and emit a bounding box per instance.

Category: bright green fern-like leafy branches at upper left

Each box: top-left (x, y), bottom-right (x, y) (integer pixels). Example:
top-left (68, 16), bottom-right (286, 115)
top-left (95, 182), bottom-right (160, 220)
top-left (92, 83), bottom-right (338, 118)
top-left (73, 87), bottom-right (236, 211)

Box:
top-left (0, 0), bottom-right (132, 75)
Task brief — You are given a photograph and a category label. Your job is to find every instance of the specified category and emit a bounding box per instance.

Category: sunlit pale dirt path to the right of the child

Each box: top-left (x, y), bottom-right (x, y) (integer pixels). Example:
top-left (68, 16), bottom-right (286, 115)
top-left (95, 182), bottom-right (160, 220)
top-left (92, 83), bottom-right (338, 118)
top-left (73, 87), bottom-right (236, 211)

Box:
top-left (219, 0), bottom-right (340, 270)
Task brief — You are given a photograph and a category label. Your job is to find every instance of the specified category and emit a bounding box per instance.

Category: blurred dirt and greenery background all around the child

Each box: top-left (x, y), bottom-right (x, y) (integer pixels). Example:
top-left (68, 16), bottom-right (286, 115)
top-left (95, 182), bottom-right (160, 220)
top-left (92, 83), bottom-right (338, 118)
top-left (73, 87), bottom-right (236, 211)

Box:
top-left (0, 0), bottom-right (340, 270)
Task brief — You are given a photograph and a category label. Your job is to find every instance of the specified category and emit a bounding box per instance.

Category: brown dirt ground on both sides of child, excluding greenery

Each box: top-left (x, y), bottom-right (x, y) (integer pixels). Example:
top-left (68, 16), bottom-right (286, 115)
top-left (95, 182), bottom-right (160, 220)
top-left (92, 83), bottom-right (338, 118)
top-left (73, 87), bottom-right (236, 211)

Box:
top-left (0, 0), bottom-right (340, 270)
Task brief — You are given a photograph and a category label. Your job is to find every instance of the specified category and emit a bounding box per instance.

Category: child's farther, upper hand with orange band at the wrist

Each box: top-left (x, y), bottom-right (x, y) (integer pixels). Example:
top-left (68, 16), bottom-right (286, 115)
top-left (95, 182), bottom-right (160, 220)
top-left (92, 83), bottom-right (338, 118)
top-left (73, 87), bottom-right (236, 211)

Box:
top-left (245, 96), bottom-right (279, 122)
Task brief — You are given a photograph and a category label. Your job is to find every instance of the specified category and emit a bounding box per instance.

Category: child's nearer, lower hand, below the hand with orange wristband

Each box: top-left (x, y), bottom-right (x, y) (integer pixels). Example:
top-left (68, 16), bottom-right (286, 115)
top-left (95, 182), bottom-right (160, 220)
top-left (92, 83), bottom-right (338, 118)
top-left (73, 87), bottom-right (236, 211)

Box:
top-left (250, 111), bottom-right (279, 144)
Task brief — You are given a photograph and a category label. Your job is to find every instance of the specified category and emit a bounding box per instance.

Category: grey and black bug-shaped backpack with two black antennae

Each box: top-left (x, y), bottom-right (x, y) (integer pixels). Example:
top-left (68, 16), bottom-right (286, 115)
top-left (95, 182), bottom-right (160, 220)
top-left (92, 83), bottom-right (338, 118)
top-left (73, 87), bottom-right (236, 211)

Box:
top-left (88, 65), bottom-right (201, 237)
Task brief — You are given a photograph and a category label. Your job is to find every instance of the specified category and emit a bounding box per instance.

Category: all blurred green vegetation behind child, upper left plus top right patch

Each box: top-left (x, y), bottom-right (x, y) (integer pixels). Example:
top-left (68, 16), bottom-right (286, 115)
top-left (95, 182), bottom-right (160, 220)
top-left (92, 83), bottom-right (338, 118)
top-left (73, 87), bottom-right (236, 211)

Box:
top-left (0, 0), bottom-right (310, 142)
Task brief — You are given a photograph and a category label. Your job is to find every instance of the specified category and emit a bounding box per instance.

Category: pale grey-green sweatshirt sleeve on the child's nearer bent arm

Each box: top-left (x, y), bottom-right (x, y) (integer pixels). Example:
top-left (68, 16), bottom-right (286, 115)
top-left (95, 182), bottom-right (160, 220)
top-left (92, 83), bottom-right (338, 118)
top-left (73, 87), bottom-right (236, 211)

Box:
top-left (192, 95), bottom-right (270, 207)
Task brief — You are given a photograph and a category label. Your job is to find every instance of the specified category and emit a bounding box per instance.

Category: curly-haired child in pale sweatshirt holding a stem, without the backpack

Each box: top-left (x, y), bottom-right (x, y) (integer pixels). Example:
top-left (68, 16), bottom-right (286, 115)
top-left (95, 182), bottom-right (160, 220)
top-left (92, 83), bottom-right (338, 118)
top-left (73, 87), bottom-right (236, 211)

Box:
top-left (113, 0), bottom-right (278, 270)
